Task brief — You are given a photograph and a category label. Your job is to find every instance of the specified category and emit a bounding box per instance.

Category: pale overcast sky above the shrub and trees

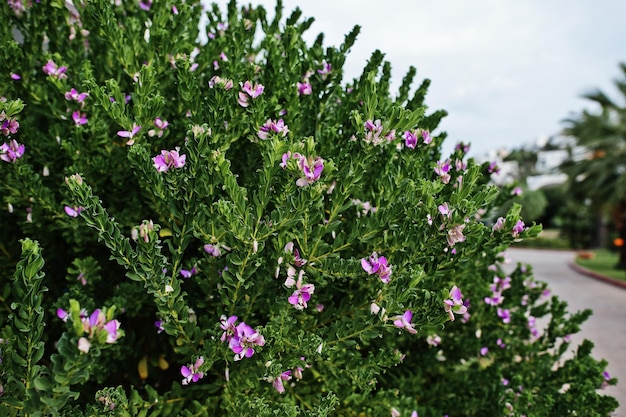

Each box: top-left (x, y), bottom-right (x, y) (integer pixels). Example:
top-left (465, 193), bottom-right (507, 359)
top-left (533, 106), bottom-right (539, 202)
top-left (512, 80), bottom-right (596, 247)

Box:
top-left (210, 0), bottom-right (626, 156)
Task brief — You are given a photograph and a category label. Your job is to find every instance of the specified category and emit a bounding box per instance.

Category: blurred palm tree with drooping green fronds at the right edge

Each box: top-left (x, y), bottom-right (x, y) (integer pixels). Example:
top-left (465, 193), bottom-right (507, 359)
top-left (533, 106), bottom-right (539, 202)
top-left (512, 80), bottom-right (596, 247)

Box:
top-left (562, 63), bottom-right (626, 268)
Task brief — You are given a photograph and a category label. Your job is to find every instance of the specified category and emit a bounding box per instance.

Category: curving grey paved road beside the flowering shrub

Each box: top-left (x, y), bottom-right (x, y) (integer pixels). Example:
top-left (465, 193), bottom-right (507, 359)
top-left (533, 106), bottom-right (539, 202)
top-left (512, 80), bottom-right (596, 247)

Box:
top-left (507, 249), bottom-right (626, 417)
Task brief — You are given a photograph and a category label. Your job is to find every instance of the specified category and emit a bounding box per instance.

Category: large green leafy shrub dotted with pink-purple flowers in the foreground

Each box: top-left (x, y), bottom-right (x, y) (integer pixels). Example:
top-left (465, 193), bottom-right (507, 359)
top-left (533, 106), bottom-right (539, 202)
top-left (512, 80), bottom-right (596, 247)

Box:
top-left (0, 0), bottom-right (616, 416)
